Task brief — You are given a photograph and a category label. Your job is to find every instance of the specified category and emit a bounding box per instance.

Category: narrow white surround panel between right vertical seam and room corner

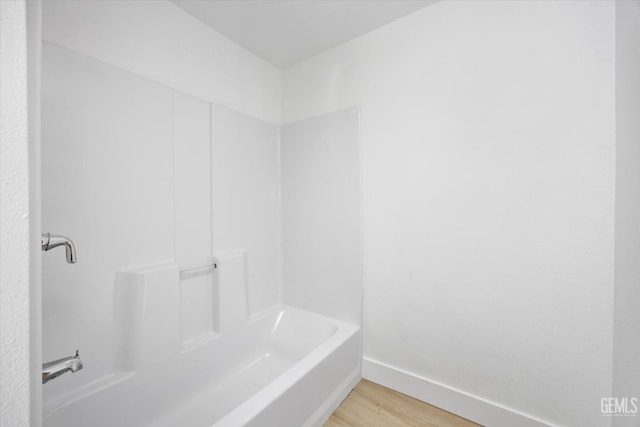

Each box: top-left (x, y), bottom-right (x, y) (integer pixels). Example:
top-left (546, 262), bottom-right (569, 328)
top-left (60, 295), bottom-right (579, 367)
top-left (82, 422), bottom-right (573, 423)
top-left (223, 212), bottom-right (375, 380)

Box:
top-left (211, 105), bottom-right (280, 314)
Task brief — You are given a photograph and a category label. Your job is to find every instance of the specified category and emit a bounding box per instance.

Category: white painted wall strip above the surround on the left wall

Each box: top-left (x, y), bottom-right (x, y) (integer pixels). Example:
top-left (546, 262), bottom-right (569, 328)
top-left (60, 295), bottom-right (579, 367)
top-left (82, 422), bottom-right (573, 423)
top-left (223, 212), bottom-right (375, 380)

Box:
top-left (43, 0), bottom-right (281, 123)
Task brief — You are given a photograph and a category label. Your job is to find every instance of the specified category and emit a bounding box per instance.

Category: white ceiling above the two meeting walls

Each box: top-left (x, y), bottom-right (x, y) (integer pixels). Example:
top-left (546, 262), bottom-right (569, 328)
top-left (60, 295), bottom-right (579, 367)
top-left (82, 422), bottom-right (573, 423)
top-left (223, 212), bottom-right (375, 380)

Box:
top-left (172, 0), bottom-right (436, 68)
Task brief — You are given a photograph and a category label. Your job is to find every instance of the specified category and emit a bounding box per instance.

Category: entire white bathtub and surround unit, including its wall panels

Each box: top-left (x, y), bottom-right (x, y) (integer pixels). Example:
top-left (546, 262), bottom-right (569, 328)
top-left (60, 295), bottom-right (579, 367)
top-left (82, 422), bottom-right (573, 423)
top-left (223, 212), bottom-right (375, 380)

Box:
top-left (43, 38), bottom-right (362, 427)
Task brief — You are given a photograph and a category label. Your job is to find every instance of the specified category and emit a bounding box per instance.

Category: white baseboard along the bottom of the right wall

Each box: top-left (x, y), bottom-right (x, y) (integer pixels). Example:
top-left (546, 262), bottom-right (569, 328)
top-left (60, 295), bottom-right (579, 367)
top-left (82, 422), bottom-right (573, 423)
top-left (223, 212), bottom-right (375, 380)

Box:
top-left (363, 357), bottom-right (556, 427)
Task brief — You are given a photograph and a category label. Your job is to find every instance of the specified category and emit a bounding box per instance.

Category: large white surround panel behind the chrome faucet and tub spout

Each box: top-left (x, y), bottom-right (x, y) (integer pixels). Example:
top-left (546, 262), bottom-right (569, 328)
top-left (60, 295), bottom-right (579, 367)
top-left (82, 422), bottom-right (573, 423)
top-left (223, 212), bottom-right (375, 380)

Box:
top-left (42, 43), bottom-right (174, 399)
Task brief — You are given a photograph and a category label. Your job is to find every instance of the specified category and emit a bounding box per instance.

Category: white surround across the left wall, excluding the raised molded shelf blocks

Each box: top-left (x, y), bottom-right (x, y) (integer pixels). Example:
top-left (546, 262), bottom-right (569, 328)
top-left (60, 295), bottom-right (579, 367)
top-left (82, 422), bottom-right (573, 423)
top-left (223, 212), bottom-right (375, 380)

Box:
top-left (42, 43), bottom-right (279, 403)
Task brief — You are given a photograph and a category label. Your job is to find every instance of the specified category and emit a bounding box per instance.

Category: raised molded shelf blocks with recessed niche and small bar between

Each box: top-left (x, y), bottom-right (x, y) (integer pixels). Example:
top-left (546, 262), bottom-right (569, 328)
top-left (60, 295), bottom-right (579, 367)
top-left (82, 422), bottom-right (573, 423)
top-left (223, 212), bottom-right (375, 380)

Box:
top-left (115, 251), bottom-right (249, 372)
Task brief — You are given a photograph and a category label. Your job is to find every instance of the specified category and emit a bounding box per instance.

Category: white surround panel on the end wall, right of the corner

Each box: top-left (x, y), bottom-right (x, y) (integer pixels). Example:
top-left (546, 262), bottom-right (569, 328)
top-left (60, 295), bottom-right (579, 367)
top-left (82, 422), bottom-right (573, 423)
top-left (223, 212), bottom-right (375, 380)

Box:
top-left (280, 107), bottom-right (362, 325)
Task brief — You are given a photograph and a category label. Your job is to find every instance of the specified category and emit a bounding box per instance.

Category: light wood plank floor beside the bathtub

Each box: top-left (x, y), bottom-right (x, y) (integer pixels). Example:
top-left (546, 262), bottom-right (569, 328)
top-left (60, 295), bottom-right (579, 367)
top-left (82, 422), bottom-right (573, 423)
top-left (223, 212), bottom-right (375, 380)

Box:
top-left (324, 380), bottom-right (480, 427)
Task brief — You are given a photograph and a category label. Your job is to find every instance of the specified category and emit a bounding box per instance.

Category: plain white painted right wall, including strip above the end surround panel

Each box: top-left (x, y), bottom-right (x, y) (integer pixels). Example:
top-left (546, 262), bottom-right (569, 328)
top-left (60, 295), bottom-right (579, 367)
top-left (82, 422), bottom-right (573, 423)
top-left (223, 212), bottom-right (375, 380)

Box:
top-left (283, 1), bottom-right (615, 426)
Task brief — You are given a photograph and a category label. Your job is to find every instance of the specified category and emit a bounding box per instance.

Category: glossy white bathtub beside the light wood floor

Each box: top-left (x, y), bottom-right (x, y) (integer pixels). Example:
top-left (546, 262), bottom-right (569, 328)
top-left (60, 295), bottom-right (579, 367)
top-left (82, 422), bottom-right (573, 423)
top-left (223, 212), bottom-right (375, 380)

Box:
top-left (44, 306), bottom-right (360, 427)
